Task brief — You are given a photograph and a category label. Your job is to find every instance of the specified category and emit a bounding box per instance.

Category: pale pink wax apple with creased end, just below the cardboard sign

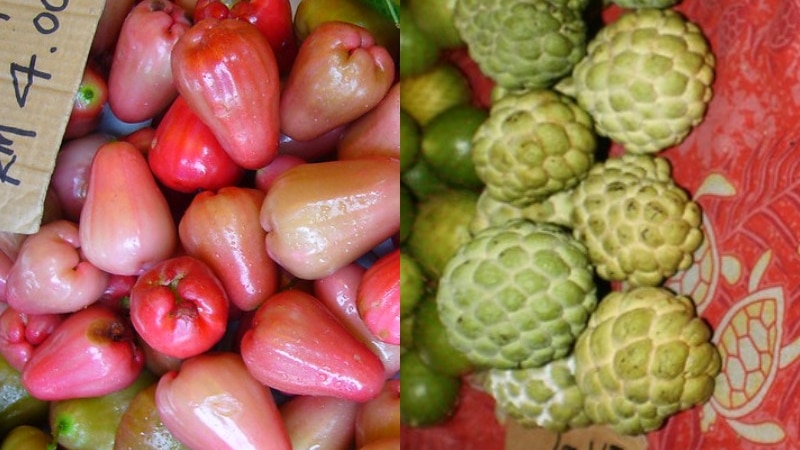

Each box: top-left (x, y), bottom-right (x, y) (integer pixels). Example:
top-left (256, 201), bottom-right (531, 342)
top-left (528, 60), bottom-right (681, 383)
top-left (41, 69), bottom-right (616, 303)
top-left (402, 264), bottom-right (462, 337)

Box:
top-left (6, 220), bottom-right (109, 314)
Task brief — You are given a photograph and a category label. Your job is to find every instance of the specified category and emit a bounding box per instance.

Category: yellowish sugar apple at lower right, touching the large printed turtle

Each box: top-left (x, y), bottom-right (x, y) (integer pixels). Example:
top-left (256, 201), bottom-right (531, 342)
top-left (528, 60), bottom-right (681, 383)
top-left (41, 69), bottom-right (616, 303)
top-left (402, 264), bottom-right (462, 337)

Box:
top-left (574, 287), bottom-right (721, 434)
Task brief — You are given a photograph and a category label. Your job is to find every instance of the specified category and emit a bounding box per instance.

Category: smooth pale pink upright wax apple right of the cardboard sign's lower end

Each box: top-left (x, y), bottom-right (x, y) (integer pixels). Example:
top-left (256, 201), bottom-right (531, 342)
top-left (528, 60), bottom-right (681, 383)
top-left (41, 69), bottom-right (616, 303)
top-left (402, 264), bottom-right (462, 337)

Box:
top-left (78, 141), bottom-right (178, 275)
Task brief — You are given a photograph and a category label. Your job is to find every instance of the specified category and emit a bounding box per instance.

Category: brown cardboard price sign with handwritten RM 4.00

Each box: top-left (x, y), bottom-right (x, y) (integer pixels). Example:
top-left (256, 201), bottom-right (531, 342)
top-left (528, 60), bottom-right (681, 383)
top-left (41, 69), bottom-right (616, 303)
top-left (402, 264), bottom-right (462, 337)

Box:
top-left (0, 0), bottom-right (105, 234)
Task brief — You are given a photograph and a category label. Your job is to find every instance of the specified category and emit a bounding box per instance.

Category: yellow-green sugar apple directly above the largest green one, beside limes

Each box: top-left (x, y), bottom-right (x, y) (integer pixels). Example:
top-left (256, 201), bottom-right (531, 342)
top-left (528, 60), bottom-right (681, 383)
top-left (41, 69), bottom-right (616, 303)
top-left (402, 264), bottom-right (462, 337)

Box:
top-left (472, 89), bottom-right (597, 206)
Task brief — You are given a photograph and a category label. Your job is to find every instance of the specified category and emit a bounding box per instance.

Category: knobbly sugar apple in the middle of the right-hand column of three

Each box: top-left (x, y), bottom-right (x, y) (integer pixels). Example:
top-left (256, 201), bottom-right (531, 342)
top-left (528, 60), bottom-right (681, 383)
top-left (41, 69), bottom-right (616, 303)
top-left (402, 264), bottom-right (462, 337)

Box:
top-left (571, 154), bottom-right (704, 286)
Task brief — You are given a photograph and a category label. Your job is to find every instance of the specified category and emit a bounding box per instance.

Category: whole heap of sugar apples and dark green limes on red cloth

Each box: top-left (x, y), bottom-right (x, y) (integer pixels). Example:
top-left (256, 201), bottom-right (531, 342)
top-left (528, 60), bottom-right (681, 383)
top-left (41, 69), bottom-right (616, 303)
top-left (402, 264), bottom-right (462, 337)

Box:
top-left (400, 0), bottom-right (722, 449)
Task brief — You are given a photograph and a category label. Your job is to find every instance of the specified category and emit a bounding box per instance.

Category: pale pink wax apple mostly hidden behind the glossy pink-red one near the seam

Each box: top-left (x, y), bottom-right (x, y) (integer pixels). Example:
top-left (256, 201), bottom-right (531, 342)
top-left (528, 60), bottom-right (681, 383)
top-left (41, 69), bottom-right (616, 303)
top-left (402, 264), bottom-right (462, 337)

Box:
top-left (312, 263), bottom-right (400, 378)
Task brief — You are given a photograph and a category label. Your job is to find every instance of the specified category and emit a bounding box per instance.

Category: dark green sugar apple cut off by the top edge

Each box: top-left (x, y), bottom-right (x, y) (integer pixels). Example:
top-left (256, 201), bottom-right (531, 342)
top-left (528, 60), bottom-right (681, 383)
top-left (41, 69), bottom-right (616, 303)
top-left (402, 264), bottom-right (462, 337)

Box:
top-left (453, 0), bottom-right (587, 88)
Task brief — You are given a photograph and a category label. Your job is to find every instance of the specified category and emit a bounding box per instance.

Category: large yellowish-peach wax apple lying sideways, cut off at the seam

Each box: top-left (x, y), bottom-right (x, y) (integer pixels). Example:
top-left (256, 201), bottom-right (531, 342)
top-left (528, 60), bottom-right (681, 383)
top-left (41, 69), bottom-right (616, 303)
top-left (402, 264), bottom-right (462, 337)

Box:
top-left (260, 158), bottom-right (400, 280)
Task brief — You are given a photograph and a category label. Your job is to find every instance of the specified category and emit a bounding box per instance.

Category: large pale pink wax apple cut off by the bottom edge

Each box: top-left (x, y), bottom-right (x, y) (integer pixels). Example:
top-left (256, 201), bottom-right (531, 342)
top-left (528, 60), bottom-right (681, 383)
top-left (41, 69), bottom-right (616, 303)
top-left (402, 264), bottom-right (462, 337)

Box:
top-left (155, 353), bottom-right (292, 450)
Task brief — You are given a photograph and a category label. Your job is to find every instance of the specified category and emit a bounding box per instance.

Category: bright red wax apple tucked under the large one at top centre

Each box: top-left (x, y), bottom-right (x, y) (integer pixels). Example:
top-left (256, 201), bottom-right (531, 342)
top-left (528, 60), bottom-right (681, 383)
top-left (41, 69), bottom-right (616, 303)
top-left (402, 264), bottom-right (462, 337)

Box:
top-left (147, 96), bottom-right (244, 193)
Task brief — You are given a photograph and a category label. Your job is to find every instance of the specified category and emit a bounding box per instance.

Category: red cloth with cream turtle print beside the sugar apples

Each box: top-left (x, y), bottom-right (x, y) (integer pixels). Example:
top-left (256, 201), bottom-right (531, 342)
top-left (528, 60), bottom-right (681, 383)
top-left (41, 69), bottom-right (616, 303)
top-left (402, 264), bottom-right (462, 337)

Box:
top-left (403, 0), bottom-right (800, 450)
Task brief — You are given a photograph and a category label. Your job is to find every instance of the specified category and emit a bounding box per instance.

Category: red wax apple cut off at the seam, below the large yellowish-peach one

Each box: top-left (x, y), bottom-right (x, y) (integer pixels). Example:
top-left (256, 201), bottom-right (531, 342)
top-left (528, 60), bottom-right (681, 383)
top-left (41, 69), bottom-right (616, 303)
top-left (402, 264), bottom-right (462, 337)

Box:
top-left (356, 248), bottom-right (400, 345)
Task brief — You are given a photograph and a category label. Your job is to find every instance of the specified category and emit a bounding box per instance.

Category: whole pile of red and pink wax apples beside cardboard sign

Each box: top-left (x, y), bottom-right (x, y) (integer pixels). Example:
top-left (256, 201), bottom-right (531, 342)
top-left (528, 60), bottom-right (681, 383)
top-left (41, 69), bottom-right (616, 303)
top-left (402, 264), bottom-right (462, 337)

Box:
top-left (0, 0), bottom-right (400, 450)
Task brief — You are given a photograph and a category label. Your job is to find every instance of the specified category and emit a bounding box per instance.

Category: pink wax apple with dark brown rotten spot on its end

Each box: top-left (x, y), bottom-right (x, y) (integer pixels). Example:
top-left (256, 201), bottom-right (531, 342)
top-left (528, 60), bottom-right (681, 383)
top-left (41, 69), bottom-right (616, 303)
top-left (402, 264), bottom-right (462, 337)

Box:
top-left (22, 305), bottom-right (144, 400)
